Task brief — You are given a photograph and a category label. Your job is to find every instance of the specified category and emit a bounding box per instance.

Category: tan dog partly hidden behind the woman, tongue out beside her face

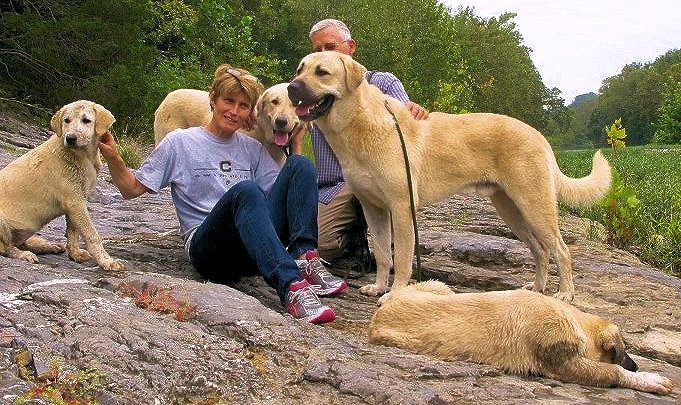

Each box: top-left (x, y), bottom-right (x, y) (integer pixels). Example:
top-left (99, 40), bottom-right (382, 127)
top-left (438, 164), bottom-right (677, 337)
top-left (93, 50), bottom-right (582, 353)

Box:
top-left (154, 83), bottom-right (300, 166)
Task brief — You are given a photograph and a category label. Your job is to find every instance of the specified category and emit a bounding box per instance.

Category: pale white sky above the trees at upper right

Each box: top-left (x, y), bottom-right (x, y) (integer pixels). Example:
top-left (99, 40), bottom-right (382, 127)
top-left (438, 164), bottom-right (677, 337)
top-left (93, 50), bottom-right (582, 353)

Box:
top-left (441, 0), bottom-right (681, 104)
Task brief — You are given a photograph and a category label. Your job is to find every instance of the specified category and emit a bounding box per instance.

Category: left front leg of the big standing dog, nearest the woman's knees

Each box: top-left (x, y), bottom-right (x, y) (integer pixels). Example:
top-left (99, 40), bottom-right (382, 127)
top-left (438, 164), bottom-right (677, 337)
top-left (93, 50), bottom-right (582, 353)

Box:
top-left (359, 199), bottom-right (392, 296)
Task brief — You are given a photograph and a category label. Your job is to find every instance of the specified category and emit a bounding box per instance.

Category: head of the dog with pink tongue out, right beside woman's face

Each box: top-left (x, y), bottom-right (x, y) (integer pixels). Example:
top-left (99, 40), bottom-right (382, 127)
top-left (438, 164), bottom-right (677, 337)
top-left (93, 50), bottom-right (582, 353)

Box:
top-left (255, 83), bottom-right (300, 148)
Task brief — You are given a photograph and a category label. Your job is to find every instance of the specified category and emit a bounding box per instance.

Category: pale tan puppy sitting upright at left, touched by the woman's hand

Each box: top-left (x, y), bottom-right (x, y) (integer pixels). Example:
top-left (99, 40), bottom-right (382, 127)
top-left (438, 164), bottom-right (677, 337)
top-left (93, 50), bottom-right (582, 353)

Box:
top-left (0, 100), bottom-right (125, 270)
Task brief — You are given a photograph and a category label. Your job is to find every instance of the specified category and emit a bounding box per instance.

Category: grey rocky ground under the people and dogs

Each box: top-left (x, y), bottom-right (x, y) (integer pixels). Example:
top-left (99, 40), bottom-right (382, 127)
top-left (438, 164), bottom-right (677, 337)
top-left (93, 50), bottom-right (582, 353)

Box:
top-left (0, 112), bottom-right (681, 404)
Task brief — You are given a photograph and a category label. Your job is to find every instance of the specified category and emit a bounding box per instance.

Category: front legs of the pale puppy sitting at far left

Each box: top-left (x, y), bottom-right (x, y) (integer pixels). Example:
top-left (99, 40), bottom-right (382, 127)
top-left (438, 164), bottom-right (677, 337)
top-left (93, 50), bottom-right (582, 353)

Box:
top-left (66, 202), bottom-right (125, 270)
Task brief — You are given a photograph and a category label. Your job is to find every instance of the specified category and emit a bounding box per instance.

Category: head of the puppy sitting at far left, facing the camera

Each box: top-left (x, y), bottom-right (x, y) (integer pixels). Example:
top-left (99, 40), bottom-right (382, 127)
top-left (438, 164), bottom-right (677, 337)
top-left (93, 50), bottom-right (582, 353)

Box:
top-left (50, 100), bottom-right (116, 148)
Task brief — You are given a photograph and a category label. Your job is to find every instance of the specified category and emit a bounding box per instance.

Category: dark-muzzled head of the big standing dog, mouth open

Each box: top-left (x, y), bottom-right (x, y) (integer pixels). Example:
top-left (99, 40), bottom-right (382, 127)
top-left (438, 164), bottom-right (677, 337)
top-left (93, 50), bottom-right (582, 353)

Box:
top-left (288, 51), bottom-right (366, 121)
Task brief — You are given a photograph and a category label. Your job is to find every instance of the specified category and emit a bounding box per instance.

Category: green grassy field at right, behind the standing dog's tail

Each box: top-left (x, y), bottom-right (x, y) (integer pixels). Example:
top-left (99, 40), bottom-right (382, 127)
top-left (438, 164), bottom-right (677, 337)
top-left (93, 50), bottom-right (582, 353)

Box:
top-left (556, 145), bottom-right (681, 276)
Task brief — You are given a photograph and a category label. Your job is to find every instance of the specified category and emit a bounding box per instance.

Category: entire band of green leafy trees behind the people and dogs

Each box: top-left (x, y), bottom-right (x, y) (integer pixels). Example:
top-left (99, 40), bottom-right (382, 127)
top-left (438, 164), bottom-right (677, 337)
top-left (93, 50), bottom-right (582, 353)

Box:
top-left (0, 0), bottom-right (681, 144)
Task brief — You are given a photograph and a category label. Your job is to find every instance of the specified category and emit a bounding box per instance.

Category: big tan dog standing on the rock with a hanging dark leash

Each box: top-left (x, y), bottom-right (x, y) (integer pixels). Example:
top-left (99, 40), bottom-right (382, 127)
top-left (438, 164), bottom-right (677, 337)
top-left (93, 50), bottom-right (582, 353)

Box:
top-left (288, 51), bottom-right (610, 301)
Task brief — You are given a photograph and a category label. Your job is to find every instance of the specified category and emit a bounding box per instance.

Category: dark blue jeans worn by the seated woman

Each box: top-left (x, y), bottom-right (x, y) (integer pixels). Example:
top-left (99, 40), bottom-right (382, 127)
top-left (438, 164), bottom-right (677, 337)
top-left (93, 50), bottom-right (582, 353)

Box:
top-left (189, 155), bottom-right (317, 302)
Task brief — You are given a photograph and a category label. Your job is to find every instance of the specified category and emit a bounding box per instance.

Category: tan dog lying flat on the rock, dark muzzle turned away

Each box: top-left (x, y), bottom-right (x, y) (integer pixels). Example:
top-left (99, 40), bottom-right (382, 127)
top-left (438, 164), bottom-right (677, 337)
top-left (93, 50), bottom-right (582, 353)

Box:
top-left (369, 281), bottom-right (673, 394)
